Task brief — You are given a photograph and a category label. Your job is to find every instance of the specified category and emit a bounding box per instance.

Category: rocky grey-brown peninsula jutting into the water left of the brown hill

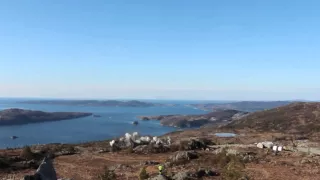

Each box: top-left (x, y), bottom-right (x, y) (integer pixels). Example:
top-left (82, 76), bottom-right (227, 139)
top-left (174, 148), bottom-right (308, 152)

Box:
top-left (139, 110), bottom-right (247, 128)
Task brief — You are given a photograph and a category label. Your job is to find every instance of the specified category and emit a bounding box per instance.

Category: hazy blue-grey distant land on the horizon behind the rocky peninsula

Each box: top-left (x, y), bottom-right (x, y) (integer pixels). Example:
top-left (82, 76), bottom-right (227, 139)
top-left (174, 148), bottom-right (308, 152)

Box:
top-left (188, 101), bottom-right (294, 112)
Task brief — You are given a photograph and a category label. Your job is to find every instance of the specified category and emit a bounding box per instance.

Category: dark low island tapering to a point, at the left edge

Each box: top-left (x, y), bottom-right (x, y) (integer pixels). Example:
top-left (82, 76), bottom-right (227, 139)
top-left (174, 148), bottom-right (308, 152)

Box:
top-left (0, 109), bottom-right (92, 126)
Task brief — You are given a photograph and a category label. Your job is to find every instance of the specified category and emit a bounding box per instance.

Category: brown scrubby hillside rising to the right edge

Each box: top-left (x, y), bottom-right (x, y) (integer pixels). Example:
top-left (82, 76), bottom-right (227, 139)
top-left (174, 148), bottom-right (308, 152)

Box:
top-left (226, 102), bottom-right (320, 134)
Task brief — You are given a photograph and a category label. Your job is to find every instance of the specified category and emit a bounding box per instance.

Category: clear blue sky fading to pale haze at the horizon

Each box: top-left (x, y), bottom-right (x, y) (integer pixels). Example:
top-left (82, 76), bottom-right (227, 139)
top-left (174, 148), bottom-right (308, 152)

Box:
top-left (0, 0), bottom-right (320, 100)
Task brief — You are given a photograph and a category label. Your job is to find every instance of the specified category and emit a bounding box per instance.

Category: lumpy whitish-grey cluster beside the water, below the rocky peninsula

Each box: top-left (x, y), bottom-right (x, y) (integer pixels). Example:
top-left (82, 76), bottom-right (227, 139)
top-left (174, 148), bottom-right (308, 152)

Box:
top-left (110, 132), bottom-right (171, 147)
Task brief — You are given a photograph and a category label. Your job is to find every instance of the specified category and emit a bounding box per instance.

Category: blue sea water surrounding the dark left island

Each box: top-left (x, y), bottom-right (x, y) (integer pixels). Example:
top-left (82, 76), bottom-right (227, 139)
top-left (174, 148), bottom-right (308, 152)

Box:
top-left (0, 99), bottom-right (210, 148)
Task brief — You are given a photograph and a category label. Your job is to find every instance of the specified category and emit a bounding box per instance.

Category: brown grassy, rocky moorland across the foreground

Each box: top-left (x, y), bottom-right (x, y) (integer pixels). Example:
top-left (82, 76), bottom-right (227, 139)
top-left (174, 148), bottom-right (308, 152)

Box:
top-left (0, 130), bottom-right (320, 180)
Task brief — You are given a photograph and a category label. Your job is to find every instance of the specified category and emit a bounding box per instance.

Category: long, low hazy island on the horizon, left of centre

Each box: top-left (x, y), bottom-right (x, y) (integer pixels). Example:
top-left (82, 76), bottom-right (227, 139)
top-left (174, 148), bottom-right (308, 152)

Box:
top-left (19, 100), bottom-right (170, 107)
